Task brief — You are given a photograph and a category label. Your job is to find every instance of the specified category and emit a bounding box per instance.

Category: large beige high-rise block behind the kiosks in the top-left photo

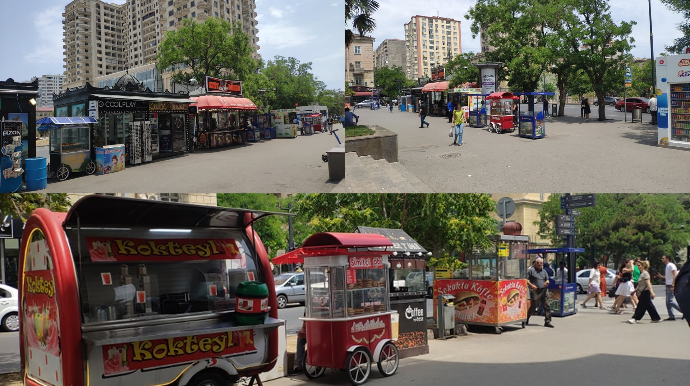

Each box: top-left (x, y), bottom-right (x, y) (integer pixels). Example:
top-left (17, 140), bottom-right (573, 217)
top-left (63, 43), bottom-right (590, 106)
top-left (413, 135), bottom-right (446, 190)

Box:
top-left (62, 0), bottom-right (259, 89)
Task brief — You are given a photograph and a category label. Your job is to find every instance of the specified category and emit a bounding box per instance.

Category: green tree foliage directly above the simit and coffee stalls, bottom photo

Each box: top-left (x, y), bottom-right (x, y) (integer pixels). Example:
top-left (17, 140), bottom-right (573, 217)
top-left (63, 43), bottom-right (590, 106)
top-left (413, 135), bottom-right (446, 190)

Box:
top-left (290, 194), bottom-right (496, 257)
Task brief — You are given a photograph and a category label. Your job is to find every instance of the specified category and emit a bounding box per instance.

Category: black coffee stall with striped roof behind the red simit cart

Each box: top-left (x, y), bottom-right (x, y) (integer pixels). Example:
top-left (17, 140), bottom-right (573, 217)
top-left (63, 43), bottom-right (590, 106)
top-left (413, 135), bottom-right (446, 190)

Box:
top-left (356, 227), bottom-right (433, 358)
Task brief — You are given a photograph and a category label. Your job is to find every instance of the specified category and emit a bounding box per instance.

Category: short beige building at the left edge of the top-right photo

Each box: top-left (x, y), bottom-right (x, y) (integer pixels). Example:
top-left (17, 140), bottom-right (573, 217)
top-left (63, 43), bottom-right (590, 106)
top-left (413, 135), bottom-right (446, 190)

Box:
top-left (345, 35), bottom-right (374, 87)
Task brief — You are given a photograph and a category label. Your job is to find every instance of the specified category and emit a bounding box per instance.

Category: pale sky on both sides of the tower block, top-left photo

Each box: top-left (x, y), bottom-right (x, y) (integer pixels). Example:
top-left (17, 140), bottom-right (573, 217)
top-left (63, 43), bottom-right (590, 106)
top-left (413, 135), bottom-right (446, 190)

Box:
top-left (0, 0), bottom-right (345, 89)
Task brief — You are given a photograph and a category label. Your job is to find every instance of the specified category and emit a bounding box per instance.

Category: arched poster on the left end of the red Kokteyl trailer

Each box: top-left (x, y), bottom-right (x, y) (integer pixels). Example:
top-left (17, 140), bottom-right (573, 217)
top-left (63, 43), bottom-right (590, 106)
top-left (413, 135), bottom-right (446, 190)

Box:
top-left (21, 231), bottom-right (62, 385)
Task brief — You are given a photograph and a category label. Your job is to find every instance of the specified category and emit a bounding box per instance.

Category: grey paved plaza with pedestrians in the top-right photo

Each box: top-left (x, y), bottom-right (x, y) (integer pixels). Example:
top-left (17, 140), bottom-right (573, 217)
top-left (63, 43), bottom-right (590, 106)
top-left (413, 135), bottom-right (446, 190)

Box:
top-left (355, 105), bottom-right (690, 193)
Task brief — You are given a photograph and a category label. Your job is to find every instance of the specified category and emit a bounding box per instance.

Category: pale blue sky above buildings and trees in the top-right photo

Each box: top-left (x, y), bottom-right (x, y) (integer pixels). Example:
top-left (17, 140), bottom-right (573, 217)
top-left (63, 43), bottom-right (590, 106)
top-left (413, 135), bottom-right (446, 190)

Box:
top-left (371, 0), bottom-right (683, 58)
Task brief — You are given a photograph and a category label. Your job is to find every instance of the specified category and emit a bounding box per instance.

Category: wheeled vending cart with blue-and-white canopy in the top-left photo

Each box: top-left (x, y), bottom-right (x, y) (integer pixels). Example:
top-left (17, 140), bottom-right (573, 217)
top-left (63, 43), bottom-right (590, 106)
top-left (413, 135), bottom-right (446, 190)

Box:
top-left (36, 117), bottom-right (98, 181)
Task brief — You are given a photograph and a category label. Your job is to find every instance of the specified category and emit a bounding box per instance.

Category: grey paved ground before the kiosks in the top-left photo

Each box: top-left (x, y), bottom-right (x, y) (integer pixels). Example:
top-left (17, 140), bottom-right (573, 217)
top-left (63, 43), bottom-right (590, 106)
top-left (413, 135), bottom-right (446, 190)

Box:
top-left (39, 129), bottom-right (344, 193)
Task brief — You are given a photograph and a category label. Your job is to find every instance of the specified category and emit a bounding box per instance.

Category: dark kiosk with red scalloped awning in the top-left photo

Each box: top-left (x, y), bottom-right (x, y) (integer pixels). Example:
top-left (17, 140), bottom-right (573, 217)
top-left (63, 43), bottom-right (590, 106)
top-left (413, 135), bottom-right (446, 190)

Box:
top-left (190, 95), bottom-right (257, 149)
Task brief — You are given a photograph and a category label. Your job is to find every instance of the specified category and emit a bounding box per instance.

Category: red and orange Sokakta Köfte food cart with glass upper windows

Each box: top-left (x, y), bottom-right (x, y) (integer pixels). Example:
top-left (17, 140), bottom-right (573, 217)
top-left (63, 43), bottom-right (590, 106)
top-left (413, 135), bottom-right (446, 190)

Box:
top-left (434, 235), bottom-right (529, 334)
